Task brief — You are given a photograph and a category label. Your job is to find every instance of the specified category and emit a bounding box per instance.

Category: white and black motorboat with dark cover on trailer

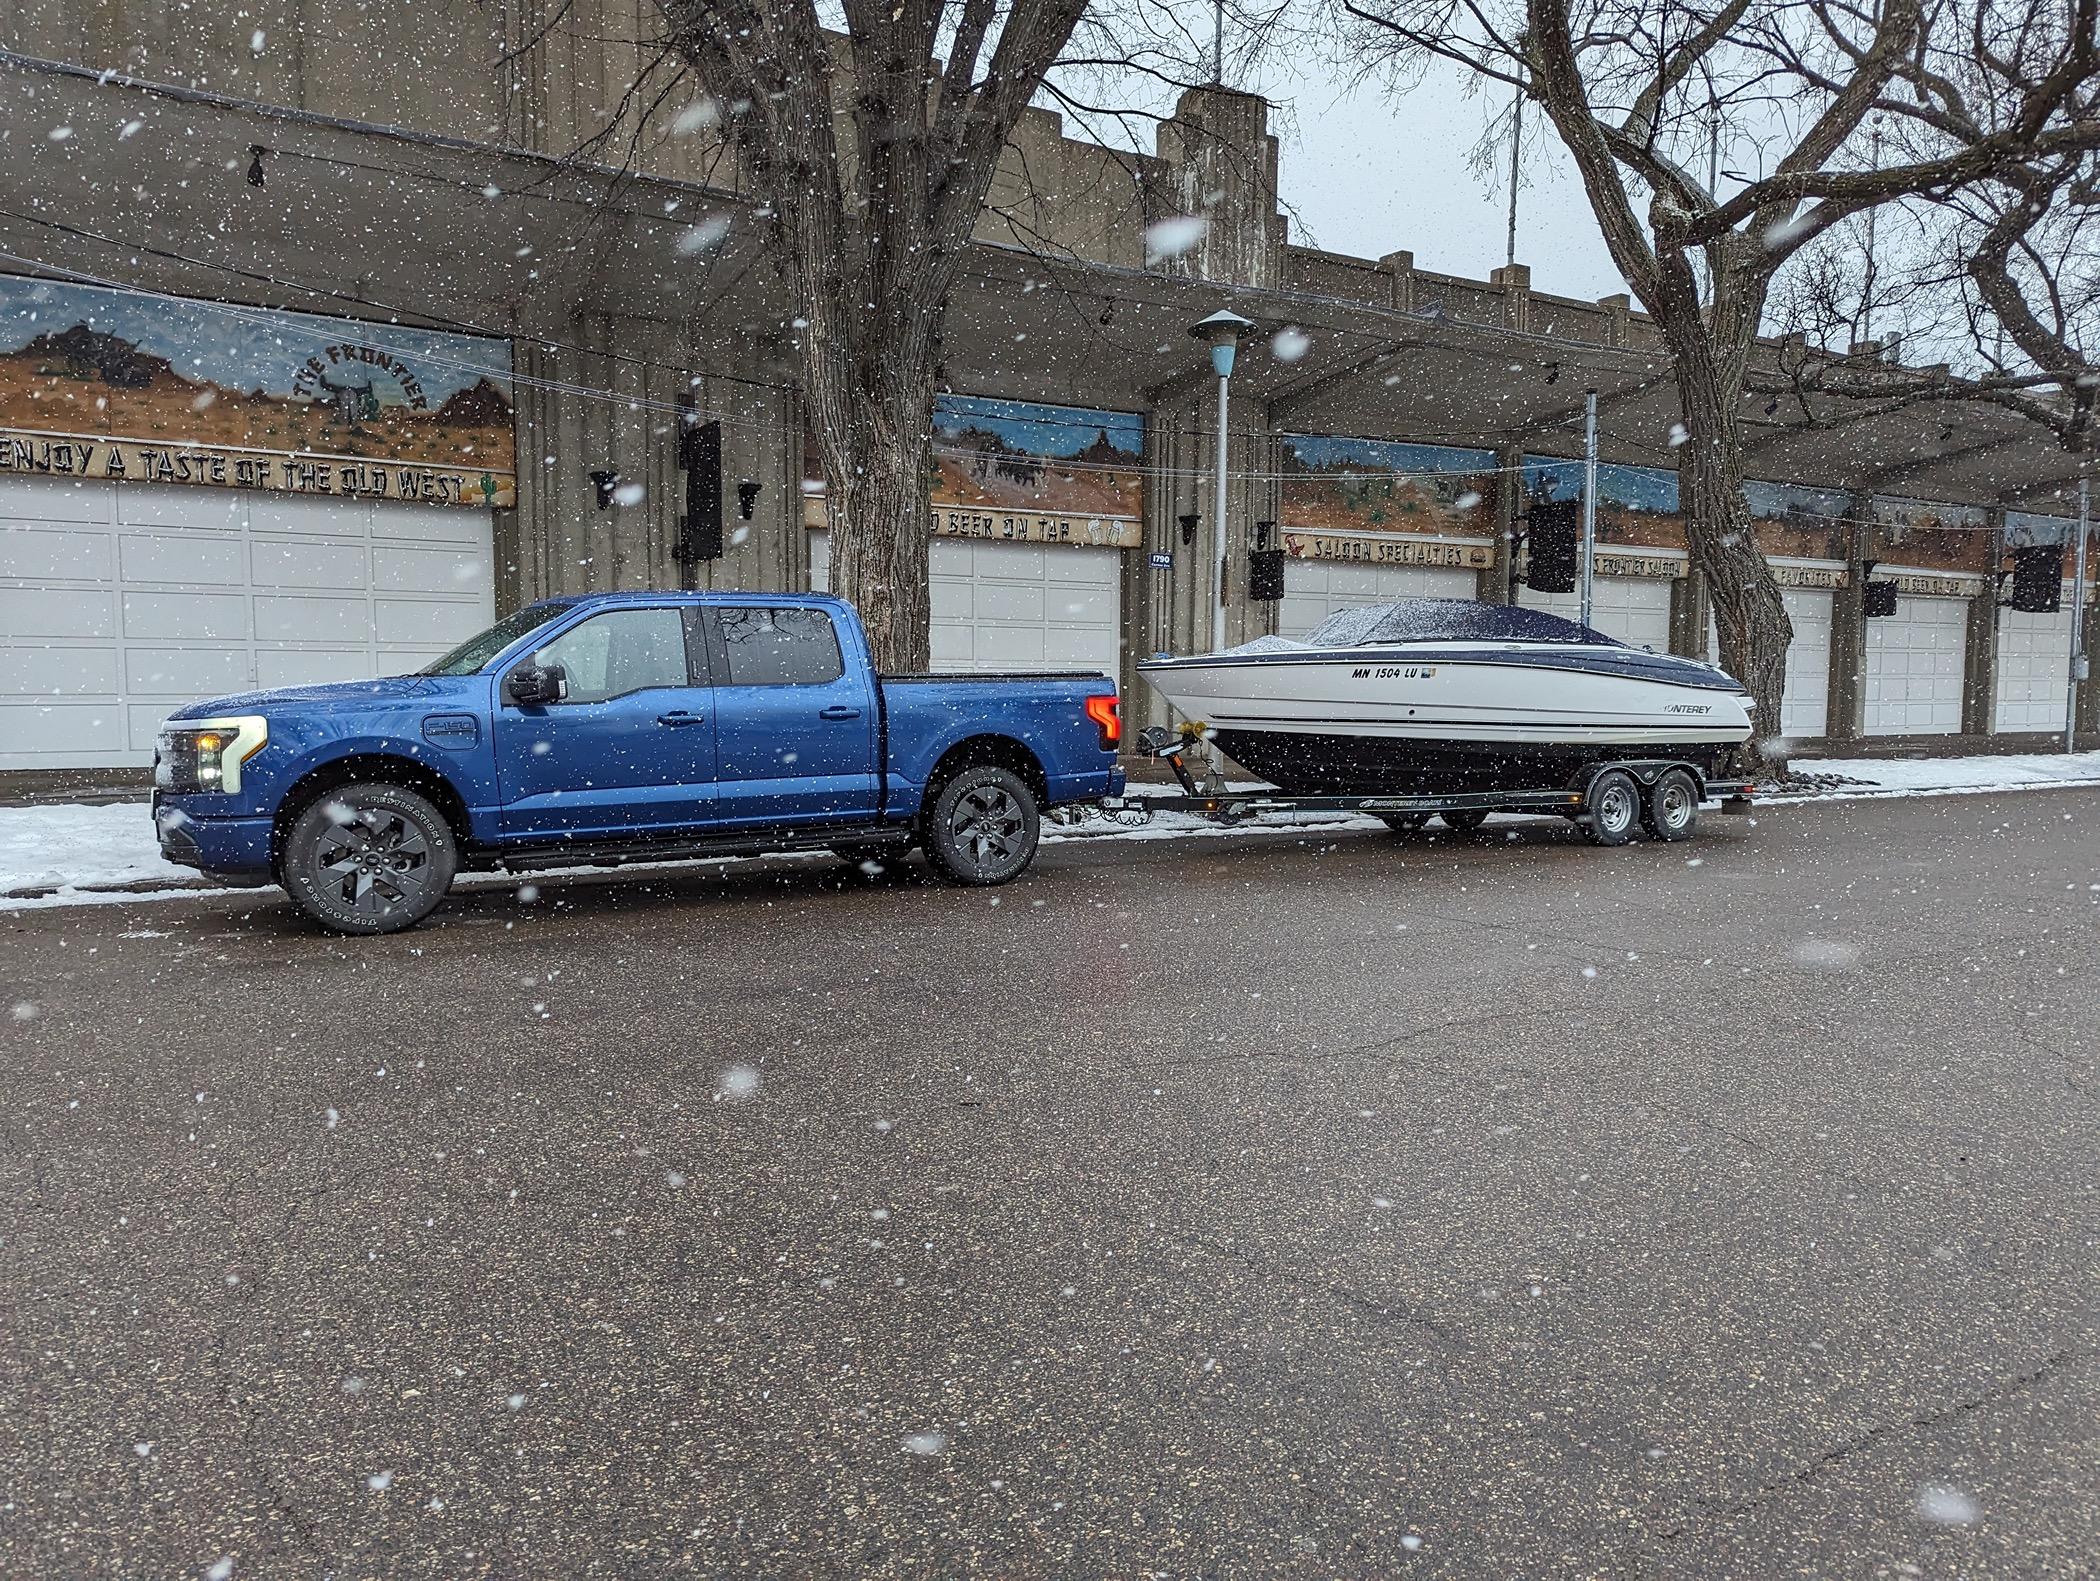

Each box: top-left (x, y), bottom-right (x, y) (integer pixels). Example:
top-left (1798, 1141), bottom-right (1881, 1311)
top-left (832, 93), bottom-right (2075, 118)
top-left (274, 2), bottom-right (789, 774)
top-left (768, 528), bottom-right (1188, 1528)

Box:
top-left (1138, 598), bottom-right (1751, 796)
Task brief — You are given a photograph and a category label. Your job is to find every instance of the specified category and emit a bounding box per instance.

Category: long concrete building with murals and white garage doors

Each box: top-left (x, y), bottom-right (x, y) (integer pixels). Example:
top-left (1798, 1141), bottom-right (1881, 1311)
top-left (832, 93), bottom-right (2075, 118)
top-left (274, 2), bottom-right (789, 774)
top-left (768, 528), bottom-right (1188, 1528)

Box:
top-left (0, 0), bottom-right (2094, 768)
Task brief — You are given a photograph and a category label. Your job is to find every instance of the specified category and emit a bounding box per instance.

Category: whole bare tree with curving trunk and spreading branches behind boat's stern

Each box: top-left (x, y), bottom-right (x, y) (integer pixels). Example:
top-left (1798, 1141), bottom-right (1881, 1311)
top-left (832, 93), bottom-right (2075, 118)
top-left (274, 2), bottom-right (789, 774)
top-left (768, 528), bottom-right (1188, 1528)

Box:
top-left (1340, 0), bottom-right (2100, 760)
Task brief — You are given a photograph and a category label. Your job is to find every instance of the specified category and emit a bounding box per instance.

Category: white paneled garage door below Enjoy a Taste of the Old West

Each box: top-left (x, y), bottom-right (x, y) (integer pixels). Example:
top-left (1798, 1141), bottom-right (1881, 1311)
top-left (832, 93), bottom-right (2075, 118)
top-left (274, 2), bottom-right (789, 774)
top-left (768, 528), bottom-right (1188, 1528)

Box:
top-left (0, 479), bottom-right (496, 768)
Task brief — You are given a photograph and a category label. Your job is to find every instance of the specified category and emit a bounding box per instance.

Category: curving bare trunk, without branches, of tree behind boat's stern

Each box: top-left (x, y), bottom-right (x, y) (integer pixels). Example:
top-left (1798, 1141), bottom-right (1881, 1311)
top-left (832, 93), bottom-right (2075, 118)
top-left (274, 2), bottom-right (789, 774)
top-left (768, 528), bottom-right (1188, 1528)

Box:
top-left (1665, 325), bottom-right (1793, 768)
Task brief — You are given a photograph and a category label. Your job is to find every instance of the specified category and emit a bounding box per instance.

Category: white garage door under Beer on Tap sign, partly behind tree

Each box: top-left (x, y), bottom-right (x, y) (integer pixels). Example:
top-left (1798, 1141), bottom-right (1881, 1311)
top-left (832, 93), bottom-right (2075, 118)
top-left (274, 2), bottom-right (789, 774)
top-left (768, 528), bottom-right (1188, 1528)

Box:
top-left (809, 533), bottom-right (1124, 676)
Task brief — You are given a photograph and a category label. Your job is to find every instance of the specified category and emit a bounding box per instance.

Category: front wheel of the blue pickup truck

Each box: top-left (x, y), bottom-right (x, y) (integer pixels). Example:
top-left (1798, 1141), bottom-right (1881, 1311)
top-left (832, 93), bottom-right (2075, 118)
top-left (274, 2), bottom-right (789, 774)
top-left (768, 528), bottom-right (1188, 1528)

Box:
top-left (277, 781), bottom-right (460, 934)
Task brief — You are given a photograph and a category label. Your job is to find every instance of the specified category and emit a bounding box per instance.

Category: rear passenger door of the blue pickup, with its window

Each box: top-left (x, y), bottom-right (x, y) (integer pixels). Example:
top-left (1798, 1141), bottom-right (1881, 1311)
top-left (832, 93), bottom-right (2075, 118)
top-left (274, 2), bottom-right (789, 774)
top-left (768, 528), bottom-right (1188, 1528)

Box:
top-left (704, 603), bottom-right (876, 827)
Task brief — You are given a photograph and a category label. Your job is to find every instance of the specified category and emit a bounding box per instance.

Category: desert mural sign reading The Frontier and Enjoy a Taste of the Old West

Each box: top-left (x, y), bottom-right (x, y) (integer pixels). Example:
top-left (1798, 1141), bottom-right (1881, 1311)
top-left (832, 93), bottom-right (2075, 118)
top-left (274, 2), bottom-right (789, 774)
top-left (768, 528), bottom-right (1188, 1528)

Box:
top-left (0, 275), bottom-right (517, 508)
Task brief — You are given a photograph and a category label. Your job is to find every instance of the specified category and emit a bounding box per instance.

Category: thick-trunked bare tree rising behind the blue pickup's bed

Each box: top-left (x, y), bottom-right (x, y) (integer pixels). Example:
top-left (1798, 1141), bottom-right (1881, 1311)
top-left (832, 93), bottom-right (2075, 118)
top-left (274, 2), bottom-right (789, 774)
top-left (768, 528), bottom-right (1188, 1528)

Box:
top-left (662, 0), bottom-right (1088, 670)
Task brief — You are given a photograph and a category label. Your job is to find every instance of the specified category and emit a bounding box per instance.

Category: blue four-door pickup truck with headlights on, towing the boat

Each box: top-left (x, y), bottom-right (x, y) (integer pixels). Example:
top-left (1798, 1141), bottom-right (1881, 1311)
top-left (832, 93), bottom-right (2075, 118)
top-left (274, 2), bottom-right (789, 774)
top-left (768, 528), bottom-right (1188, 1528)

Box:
top-left (153, 592), bottom-right (1124, 934)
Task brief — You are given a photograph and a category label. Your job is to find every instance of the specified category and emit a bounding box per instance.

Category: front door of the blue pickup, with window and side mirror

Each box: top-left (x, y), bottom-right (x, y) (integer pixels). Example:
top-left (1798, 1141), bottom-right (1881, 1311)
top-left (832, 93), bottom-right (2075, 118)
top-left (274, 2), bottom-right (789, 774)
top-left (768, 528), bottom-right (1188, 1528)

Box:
top-left (494, 605), bottom-right (716, 838)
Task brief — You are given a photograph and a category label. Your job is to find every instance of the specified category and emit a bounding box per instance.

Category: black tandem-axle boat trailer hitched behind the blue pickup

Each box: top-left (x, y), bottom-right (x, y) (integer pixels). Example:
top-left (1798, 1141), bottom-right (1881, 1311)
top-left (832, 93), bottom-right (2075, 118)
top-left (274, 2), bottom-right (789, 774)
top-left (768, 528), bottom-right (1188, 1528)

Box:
top-left (1100, 724), bottom-right (1758, 846)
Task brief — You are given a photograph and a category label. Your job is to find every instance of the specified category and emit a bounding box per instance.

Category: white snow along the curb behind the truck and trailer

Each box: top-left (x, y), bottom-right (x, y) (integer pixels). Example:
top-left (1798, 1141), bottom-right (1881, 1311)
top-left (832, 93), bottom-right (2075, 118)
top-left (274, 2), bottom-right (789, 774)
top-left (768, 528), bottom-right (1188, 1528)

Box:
top-left (0, 752), bottom-right (2100, 909)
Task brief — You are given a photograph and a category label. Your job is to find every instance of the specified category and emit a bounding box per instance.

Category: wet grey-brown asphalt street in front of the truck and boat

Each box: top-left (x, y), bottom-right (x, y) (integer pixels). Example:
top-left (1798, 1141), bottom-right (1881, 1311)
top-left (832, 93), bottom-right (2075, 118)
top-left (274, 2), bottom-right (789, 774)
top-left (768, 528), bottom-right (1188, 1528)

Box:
top-left (0, 792), bottom-right (2100, 1581)
